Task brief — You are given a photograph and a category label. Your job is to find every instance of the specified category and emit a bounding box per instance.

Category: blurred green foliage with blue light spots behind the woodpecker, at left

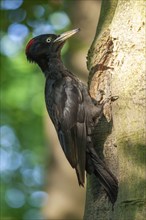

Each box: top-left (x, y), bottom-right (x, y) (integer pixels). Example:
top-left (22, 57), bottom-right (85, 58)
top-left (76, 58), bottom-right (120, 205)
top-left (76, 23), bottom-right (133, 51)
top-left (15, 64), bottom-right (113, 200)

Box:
top-left (0, 0), bottom-right (74, 220)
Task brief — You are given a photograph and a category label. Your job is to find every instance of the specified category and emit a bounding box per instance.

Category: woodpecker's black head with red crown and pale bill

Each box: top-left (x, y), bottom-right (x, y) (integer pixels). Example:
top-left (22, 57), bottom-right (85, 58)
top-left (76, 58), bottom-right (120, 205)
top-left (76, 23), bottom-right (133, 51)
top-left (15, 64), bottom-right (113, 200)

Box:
top-left (25, 28), bottom-right (79, 64)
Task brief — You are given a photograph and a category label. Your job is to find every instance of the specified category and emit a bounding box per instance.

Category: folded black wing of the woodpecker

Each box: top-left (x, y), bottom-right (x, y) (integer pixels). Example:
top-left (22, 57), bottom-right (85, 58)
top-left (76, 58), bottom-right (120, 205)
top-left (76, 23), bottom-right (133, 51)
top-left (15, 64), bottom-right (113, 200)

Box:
top-left (53, 77), bottom-right (86, 185)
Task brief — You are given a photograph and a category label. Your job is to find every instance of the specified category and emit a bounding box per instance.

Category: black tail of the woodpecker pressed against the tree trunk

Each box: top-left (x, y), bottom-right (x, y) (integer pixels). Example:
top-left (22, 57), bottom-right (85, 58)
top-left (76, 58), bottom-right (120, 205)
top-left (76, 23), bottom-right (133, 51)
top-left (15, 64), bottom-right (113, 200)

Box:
top-left (89, 147), bottom-right (118, 204)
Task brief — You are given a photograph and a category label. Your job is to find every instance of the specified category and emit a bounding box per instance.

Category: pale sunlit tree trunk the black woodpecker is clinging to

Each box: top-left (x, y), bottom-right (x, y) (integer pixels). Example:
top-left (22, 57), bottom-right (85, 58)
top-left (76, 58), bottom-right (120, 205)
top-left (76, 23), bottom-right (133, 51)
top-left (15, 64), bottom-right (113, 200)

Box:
top-left (84, 0), bottom-right (146, 220)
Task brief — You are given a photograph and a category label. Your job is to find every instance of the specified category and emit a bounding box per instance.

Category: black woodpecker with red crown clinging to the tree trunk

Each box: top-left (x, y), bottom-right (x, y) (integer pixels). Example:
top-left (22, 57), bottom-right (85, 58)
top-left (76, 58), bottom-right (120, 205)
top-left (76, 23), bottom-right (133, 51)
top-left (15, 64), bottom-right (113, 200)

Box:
top-left (25, 29), bottom-right (118, 204)
